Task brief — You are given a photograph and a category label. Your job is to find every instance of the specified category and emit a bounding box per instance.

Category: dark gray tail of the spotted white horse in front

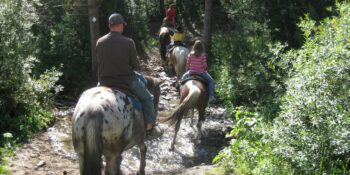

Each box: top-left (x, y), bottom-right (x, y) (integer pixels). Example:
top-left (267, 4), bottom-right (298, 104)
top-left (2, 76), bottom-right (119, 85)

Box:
top-left (82, 111), bottom-right (103, 175)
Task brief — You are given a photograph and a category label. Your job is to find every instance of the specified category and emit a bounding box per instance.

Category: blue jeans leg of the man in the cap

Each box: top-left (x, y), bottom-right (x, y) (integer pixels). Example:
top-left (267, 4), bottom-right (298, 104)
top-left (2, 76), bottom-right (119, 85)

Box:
top-left (130, 74), bottom-right (156, 124)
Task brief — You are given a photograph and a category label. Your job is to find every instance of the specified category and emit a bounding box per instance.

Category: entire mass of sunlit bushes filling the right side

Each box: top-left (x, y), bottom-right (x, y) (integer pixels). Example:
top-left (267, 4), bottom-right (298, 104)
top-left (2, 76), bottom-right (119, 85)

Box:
top-left (214, 2), bottom-right (350, 174)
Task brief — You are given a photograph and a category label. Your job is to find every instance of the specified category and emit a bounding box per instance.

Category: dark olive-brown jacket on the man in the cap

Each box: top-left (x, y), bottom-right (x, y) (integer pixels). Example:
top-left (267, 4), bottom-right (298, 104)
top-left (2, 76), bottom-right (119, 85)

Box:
top-left (96, 32), bottom-right (140, 87)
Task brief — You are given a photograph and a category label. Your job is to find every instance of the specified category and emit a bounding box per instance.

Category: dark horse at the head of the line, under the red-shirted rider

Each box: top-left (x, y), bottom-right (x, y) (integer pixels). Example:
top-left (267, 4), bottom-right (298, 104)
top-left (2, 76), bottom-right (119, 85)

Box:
top-left (159, 26), bottom-right (174, 65)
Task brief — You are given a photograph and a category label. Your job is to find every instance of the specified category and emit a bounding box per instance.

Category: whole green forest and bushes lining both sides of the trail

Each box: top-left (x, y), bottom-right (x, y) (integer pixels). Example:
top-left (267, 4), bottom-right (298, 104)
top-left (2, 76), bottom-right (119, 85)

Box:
top-left (0, 0), bottom-right (350, 174)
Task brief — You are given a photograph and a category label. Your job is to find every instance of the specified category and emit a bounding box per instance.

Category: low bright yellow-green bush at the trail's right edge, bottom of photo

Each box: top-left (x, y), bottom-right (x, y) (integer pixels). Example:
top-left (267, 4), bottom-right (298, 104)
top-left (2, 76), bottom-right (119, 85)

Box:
top-left (213, 107), bottom-right (292, 175)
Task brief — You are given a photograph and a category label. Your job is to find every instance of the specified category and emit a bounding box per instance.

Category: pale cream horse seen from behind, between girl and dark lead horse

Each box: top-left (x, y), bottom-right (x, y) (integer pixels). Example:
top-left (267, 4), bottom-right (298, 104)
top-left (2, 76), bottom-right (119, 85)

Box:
top-left (168, 46), bottom-right (190, 82)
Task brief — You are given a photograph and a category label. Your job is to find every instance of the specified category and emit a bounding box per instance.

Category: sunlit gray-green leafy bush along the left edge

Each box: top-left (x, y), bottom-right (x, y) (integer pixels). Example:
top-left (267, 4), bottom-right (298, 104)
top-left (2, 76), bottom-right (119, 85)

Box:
top-left (0, 1), bottom-right (61, 145)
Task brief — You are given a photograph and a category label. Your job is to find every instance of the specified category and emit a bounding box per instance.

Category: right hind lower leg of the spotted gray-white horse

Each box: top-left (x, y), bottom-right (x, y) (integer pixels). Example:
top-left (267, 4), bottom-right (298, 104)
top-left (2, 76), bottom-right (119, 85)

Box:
top-left (105, 153), bottom-right (122, 175)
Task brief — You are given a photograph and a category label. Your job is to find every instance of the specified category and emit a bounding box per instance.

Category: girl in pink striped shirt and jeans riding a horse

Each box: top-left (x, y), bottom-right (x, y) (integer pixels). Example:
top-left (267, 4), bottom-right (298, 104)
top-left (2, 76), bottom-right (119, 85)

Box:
top-left (182, 40), bottom-right (215, 103)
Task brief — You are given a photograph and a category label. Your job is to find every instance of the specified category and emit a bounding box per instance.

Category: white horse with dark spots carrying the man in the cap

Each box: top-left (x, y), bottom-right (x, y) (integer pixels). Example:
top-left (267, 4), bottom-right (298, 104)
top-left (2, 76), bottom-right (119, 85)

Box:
top-left (72, 77), bottom-right (162, 175)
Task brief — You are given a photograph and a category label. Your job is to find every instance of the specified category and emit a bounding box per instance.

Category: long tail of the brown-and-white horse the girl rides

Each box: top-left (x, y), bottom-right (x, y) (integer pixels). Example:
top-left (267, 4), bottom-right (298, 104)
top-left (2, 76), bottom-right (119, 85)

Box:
top-left (160, 82), bottom-right (201, 125)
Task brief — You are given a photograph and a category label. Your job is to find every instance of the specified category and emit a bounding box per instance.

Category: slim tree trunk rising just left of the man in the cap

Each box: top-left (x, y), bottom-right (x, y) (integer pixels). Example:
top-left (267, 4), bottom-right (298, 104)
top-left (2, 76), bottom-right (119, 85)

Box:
top-left (88, 0), bottom-right (100, 83)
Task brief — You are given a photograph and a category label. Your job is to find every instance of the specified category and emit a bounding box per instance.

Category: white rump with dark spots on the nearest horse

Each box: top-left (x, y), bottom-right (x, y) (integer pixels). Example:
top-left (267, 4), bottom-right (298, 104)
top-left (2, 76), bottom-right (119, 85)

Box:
top-left (73, 87), bottom-right (143, 146)
